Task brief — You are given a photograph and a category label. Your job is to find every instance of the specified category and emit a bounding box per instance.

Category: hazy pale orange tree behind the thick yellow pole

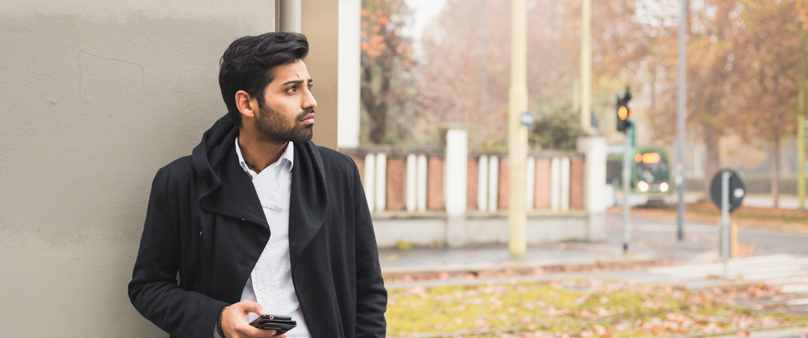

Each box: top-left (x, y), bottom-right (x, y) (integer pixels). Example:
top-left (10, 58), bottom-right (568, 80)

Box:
top-left (418, 0), bottom-right (577, 149)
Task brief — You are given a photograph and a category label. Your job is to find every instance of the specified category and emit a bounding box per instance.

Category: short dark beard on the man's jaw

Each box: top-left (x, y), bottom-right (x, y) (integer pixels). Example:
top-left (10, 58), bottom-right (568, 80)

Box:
top-left (255, 105), bottom-right (314, 143)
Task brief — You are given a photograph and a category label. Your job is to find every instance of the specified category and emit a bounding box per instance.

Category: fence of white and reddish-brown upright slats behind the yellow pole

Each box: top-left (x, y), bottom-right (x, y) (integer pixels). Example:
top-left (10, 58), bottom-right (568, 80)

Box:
top-left (341, 147), bottom-right (588, 214)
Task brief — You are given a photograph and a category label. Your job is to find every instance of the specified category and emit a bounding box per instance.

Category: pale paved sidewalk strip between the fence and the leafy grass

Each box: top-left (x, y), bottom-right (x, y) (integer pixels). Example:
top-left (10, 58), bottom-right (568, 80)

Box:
top-left (379, 211), bottom-right (808, 287)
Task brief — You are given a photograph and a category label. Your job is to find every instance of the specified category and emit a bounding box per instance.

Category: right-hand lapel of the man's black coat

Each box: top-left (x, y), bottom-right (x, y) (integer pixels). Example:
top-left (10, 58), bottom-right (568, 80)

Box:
top-left (289, 142), bottom-right (328, 276)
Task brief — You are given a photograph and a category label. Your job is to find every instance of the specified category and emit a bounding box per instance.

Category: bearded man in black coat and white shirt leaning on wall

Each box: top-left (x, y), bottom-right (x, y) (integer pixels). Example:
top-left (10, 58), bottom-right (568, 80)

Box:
top-left (129, 33), bottom-right (387, 338)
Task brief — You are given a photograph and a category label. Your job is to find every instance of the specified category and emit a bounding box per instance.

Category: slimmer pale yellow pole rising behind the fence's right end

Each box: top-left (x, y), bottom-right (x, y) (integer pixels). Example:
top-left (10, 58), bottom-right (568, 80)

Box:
top-left (580, 0), bottom-right (592, 132)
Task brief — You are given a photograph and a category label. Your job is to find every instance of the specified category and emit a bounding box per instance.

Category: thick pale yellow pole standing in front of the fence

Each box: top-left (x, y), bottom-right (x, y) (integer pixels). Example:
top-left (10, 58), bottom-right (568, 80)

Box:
top-left (508, 0), bottom-right (528, 256)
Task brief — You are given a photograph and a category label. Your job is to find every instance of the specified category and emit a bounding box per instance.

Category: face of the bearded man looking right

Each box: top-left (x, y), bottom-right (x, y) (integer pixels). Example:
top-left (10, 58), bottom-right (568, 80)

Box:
top-left (255, 60), bottom-right (317, 143)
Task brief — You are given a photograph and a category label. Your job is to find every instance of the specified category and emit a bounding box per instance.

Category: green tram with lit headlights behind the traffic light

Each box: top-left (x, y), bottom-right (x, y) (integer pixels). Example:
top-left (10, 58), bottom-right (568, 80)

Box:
top-left (606, 145), bottom-right (674, 205)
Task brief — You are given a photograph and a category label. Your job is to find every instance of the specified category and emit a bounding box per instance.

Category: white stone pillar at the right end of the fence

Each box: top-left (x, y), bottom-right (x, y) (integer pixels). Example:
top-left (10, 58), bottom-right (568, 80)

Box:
top-left (577, 135), bottom-right (606, 241)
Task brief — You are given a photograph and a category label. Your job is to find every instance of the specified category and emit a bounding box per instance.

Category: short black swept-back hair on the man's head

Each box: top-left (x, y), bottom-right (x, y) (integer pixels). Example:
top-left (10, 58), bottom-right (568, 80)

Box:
top-left (219, 32), bottom-right (309, 125)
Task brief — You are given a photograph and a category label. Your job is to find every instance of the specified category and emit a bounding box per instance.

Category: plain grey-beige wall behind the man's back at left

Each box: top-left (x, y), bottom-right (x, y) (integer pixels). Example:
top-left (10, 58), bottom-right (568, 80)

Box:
top-left (0, 0), bottom-right (274, 337)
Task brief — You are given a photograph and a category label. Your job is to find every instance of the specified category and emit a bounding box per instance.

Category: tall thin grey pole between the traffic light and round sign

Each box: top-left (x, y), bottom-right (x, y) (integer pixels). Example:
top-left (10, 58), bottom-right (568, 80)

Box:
top-left (676, 0), bottom-right (687, 242)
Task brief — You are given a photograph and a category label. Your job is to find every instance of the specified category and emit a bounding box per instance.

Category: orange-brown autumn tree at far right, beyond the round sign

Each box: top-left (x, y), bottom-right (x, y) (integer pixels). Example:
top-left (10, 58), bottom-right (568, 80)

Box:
top-left (733, 0), bottom-right (804, 208)
